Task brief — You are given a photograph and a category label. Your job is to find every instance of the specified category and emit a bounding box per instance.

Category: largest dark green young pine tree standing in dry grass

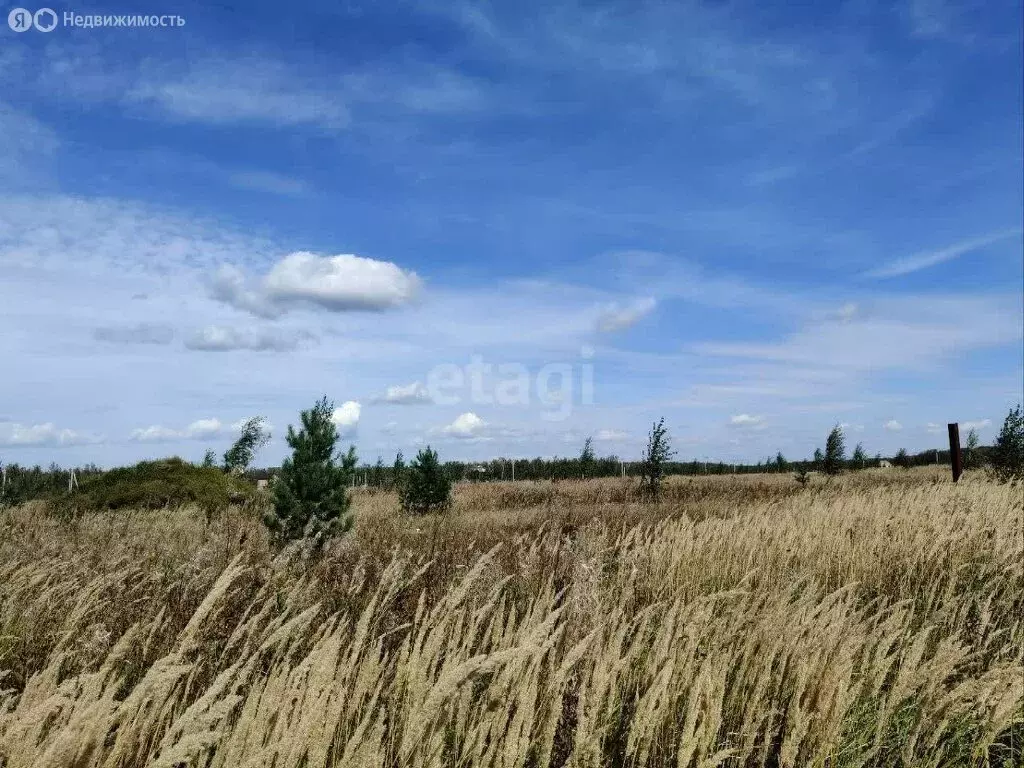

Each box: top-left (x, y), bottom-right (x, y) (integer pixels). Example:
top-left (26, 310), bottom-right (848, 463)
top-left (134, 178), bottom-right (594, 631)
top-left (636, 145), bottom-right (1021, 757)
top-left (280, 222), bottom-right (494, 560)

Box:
top-left (264, 396), bottom-right (357, 547)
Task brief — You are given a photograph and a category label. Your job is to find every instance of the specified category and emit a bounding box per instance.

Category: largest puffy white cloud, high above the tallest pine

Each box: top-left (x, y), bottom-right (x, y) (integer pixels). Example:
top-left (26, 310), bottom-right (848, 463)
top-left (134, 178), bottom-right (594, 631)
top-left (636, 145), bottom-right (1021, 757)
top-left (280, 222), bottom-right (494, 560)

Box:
top-left (213, 251), bottom-right (421, 317)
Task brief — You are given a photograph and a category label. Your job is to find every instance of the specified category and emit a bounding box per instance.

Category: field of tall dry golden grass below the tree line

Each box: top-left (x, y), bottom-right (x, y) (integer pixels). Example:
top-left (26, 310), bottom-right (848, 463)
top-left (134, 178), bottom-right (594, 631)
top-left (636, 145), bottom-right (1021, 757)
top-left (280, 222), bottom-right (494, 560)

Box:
top-left (0, 469), bottom-right (1024, 768)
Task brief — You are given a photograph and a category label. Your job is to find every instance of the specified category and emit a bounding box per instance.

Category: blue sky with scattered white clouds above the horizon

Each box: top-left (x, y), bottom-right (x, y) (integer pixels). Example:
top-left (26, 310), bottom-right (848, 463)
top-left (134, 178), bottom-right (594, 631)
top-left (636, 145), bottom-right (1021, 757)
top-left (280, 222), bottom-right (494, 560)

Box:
top-left (0, 0), bottom-right (1024, 466)
